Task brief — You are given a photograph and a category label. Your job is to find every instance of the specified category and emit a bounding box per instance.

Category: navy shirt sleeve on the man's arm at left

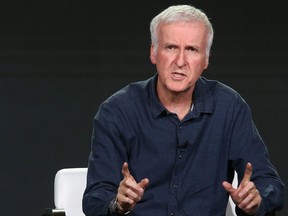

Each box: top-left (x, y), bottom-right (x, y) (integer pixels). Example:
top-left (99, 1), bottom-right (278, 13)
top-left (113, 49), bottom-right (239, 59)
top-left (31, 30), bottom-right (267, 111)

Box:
top-left (83, 102), bottom-right (127, 216)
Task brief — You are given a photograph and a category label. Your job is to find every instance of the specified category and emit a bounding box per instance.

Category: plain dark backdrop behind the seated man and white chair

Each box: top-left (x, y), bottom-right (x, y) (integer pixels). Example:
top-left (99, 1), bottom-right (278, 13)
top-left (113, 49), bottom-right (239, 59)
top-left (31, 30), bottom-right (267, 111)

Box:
top-left (0, 0), bottom-right (288, 216)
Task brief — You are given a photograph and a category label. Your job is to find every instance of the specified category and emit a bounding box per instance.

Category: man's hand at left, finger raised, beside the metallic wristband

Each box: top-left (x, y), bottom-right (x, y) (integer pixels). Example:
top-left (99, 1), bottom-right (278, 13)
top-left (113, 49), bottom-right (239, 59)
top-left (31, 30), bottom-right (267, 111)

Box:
top-left (117, 162), bottom-right (149, 213)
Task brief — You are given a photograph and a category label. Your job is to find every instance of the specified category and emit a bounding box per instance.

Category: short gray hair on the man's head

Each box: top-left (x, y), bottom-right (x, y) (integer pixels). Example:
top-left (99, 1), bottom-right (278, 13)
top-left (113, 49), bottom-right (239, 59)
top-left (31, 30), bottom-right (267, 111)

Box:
top-left (150, 5), bottom-right (214, 57)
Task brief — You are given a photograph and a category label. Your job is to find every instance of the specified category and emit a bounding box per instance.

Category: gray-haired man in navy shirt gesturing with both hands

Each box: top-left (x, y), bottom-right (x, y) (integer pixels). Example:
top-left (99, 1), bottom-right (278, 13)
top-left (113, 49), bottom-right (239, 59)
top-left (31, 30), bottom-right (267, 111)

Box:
top-left (83, 5), bottom-right (284, 216)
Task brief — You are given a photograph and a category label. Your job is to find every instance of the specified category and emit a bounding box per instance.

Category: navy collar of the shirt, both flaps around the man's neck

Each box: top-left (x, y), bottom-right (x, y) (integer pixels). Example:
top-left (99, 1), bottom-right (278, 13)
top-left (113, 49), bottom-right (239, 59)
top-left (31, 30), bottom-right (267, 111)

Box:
top-left (147, 74), bottom-right (214, 118)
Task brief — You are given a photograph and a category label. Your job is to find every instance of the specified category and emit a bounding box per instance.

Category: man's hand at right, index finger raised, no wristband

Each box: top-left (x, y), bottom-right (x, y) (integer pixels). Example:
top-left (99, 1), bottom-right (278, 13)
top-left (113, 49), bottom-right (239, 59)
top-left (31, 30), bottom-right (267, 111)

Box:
top-left (223, 163), bottom-right (262, 215)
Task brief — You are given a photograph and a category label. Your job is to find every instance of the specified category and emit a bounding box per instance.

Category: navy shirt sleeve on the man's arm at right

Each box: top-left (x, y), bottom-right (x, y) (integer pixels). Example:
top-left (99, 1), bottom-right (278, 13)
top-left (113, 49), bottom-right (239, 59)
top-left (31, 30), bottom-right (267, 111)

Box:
top-left (230, 99), bottom-right (285, 216)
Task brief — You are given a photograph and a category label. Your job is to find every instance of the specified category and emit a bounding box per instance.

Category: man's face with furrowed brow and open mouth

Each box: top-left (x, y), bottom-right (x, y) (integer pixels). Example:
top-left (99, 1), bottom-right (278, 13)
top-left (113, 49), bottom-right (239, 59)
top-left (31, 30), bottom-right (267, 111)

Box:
top-left (150, 22), bottom-right (208, 94)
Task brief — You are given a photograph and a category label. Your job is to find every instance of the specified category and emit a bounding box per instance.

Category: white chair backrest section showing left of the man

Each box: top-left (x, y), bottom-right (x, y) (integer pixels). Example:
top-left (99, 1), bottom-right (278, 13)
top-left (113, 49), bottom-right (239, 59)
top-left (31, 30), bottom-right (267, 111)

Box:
top-left (54, 168), bottom-right (87, 216)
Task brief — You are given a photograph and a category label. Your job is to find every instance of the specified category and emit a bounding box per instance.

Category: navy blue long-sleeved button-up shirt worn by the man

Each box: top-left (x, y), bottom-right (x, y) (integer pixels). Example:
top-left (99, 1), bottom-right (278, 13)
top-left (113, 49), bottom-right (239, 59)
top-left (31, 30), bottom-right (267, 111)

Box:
top-left (83, 75), bottom-right (284, 216)
